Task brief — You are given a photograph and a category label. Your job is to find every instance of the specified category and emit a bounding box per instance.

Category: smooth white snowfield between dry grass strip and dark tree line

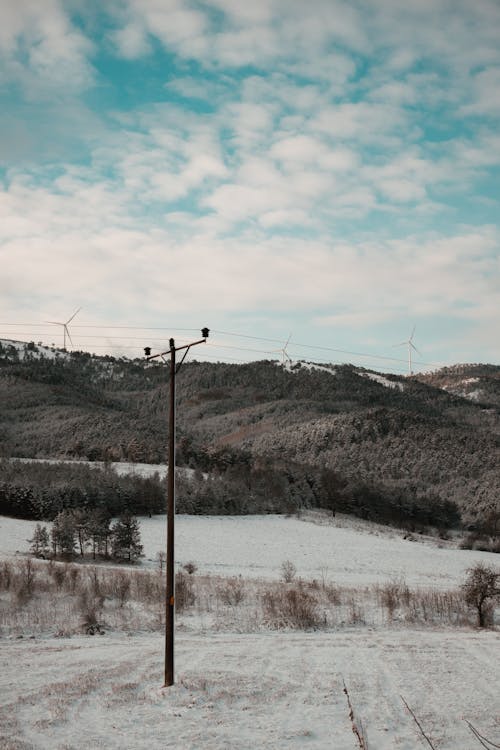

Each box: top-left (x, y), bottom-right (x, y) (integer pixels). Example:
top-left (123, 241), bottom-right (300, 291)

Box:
top-left (0, 515), bottom-right (500, 589)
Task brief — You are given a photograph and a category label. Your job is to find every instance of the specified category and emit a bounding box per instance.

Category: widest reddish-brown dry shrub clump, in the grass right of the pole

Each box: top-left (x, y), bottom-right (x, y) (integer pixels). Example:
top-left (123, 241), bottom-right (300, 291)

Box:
top-left (262, 585), bottom-right (325, 630)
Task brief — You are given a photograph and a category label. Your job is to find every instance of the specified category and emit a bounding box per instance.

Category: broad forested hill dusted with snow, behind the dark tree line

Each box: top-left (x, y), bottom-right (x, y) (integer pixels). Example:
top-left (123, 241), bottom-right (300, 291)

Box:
top-left (0, 342), bottom-right (500, 525)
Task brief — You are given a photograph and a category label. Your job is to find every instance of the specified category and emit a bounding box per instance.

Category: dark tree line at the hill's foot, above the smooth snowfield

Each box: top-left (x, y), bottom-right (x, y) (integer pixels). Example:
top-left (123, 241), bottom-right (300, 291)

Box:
top-left (0, 452), bottom-right (460, 531)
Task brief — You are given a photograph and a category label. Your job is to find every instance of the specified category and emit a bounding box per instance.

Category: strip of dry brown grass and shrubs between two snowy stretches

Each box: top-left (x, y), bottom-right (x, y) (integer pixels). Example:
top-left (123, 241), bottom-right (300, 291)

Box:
top-left (0, 558), bottom-right (492, 636)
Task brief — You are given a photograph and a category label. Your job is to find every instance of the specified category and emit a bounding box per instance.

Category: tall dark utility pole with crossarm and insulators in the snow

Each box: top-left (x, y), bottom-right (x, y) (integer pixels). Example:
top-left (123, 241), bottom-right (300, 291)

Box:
top-left (144, 328), bottom-right (209, 687)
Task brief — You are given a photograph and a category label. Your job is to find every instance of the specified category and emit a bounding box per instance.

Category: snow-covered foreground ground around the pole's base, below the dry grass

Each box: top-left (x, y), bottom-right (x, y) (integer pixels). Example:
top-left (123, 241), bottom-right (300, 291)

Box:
top-left (0, 630), bottom-right (500, 750)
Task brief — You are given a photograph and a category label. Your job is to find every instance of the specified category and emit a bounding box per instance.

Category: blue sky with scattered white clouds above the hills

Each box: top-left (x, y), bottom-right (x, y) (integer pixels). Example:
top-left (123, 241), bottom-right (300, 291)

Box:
top-left (0, 0), bottom-right (500, 374)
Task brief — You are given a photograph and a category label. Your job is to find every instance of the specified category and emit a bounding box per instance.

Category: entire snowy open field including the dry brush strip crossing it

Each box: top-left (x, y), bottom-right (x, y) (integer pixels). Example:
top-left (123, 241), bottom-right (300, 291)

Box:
top-left (0, 516), bottom-right (500, 750)
